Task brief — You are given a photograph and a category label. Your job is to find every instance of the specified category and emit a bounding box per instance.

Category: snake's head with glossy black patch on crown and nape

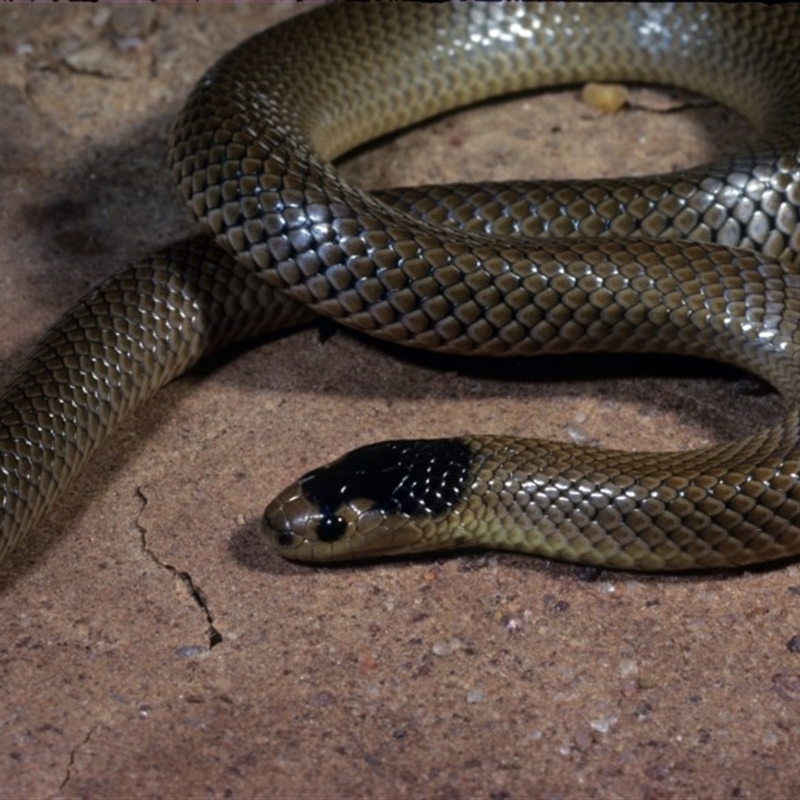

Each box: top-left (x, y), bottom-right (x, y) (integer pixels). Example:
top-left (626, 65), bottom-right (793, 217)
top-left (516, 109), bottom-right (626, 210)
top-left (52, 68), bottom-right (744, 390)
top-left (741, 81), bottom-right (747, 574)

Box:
top-left (261, 439), bottom-right (472, 561)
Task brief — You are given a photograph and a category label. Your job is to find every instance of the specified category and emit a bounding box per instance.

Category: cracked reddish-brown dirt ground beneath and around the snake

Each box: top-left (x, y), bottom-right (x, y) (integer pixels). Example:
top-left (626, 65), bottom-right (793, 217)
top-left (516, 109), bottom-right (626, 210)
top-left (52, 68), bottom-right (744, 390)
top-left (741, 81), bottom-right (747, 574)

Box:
top-left (0, 3), bottom-right (800, 800)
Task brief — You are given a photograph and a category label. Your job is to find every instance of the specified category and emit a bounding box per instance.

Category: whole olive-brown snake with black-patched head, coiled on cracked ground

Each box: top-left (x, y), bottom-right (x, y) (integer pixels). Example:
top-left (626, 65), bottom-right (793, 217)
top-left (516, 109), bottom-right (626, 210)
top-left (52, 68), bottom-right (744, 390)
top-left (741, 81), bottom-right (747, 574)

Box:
top-left (0, 2), bottom-right (800, 571)
